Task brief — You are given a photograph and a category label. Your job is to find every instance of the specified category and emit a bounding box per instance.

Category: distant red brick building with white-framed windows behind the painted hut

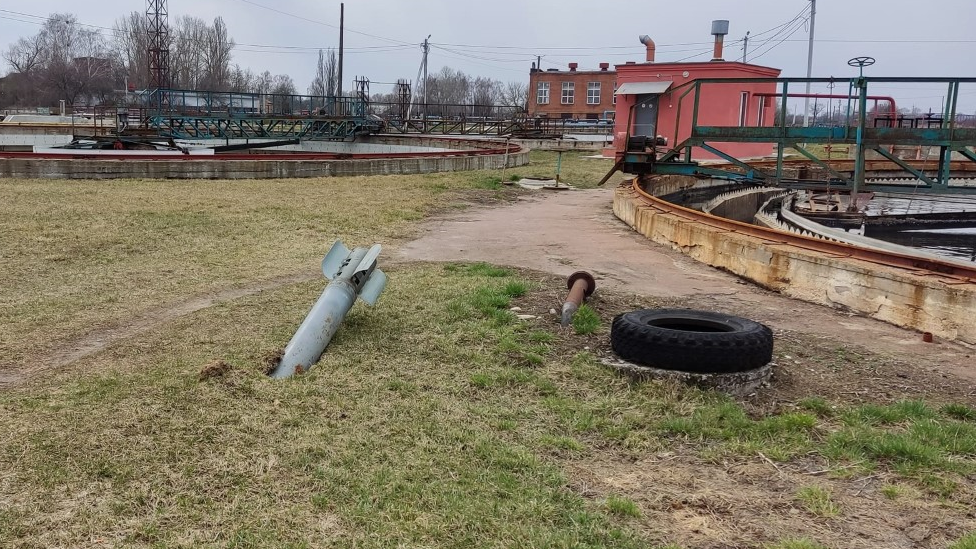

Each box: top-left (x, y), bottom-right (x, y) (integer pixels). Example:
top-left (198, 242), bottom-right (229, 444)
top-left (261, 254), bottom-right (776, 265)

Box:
top-left (528, 63), bottom-right (617, 120)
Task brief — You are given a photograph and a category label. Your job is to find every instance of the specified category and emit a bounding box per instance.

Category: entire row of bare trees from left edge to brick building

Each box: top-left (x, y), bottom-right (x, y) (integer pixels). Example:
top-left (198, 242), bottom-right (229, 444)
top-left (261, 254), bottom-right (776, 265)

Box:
top-left (0, 12), bottom-right (527, 116)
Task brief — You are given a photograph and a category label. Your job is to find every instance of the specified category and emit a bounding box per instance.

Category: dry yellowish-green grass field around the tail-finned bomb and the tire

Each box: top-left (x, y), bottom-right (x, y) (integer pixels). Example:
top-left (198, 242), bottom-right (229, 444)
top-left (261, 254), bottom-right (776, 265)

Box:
top-left (0, 153), bottom-right (976, 549)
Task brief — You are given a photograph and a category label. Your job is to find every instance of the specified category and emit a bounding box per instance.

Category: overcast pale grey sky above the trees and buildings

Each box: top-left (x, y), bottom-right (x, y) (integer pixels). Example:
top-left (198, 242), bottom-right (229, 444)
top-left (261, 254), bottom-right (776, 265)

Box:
top-left (0, 0), bottom-right (976, 112)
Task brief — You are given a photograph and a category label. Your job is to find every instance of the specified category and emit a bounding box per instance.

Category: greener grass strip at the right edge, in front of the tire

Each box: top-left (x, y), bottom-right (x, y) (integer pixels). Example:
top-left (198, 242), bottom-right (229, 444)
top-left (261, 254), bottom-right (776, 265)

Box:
top-left (659, 398), bottom-right (976, 496)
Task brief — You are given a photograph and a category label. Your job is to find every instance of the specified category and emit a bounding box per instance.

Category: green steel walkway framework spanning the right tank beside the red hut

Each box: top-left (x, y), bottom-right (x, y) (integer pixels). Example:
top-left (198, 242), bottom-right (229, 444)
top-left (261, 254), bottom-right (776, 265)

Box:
top-left (623, 77), bottom-right (976, 194)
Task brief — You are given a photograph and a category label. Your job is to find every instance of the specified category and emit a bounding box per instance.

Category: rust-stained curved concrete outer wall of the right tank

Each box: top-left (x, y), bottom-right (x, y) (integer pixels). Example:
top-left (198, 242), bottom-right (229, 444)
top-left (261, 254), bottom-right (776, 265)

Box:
top-left (613, 183), bottom-right (976, 344)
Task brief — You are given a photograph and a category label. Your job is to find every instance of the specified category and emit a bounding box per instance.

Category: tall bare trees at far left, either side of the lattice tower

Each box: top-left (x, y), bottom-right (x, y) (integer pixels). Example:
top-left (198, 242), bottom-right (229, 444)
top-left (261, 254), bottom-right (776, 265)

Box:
top-left (0, 12), bottom-right (297, 107)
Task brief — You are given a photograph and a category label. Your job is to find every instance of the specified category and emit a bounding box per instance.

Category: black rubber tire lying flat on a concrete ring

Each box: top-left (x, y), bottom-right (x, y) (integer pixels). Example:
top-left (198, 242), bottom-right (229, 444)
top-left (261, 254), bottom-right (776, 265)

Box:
top-left (610, 309), bottom-right (773, 373)
